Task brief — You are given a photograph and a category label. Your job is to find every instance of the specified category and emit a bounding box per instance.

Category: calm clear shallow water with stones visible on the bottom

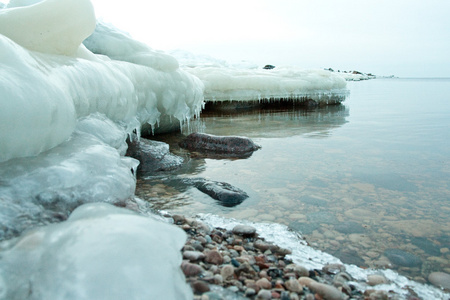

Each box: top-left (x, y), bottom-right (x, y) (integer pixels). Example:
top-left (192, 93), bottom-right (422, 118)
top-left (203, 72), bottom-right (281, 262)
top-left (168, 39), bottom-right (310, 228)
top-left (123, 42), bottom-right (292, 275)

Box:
top-left (136, 79), bottom-right (450, 281)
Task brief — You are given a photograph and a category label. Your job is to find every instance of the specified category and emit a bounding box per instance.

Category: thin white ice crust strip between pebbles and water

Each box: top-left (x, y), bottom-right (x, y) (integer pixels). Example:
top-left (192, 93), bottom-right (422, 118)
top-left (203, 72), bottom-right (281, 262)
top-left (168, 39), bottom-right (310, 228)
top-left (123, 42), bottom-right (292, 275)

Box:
top-left (198, 214), bottom-right (450, 299)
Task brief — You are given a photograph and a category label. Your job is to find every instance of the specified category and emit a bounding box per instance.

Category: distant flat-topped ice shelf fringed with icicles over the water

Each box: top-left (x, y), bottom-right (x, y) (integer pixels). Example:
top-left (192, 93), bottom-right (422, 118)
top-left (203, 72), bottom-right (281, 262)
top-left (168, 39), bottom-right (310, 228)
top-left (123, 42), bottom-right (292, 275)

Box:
top-left (172, 51), bottom-right (348, 104)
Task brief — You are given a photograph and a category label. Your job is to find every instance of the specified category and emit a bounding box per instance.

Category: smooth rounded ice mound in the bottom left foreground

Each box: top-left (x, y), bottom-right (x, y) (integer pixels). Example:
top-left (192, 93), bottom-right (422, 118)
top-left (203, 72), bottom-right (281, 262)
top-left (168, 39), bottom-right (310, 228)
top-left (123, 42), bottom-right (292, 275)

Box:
top-left (0, 203), bottom-right (193, 300)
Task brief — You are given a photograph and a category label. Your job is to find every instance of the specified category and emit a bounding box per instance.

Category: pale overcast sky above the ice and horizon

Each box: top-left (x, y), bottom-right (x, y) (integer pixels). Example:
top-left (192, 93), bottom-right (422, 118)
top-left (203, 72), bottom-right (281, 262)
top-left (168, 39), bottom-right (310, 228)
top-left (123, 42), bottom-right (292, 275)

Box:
top-left (0, 0), bottom-right (450, 77)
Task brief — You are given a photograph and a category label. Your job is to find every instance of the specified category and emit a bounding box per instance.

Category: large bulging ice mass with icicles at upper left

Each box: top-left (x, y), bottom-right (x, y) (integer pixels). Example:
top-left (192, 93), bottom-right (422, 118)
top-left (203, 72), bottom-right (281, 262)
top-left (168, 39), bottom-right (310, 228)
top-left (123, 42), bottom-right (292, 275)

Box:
top-left (0, 0), bottom-right (203, 161)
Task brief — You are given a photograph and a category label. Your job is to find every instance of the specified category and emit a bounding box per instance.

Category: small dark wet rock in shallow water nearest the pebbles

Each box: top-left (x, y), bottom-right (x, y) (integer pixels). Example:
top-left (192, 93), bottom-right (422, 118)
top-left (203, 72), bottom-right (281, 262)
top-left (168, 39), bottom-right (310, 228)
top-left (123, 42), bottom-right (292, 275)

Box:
top-left (190, 179), bottom-right (248, 207)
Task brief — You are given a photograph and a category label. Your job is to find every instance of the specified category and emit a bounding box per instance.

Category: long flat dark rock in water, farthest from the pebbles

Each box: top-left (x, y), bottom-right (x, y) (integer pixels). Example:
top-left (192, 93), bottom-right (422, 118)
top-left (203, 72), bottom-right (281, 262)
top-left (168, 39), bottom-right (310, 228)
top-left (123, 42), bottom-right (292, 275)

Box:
top-left (180, 133), bottom-right (261, 157)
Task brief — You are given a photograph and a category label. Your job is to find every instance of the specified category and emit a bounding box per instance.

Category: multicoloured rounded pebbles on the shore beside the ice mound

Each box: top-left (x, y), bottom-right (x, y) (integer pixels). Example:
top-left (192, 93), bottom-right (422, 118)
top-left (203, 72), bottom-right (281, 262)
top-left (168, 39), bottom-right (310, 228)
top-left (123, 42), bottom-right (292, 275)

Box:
top-left (166, 215), bottom-right (428, 300)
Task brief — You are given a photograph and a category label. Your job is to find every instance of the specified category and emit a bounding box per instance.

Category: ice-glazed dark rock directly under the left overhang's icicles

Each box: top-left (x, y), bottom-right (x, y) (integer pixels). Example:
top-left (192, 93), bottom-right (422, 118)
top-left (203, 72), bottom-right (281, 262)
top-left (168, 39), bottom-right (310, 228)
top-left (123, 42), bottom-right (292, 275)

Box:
top-left (126, 138), bottom-right (184, 175)
